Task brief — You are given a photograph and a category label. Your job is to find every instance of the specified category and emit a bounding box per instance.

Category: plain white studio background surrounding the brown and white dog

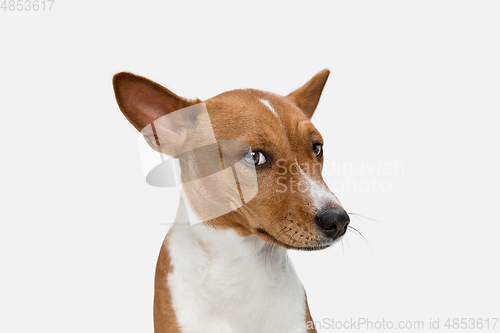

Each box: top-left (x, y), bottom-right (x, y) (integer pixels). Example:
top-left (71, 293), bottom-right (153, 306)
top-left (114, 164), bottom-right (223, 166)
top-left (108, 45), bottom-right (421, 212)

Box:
top-left (0, 0), bottom-right (500, 333)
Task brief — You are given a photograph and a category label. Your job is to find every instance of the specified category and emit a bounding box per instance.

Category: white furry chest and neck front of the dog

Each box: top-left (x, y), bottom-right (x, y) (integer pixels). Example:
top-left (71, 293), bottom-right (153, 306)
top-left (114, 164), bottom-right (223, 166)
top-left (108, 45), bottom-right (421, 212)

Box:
top-left (165, 224), bottom-right (306, 333)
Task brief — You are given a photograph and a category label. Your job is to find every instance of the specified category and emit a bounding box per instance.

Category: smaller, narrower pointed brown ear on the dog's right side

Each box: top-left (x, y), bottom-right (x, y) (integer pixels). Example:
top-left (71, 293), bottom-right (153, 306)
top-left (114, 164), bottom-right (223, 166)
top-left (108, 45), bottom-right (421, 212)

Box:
top-left (287, 69), bottom-right (330, 119)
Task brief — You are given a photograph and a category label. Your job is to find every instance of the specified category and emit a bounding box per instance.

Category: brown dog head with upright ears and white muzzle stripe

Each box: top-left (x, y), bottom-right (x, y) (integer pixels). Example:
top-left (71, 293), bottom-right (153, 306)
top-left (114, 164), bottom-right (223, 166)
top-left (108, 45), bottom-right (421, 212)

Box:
top-left (113, 70), bottom-right (349, 250)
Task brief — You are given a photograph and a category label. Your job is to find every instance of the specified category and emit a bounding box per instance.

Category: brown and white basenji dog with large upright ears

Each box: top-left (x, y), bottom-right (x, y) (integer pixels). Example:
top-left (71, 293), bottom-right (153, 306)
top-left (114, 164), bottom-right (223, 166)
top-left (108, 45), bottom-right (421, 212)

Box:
top-left (113, 69), bottom-right (349, 333)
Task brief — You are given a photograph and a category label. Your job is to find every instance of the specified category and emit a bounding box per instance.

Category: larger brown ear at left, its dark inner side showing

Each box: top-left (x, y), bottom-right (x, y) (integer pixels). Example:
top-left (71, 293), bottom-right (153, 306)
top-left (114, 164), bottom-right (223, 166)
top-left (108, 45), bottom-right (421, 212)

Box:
top-left (113, 72), bottom-right (201, 154)
